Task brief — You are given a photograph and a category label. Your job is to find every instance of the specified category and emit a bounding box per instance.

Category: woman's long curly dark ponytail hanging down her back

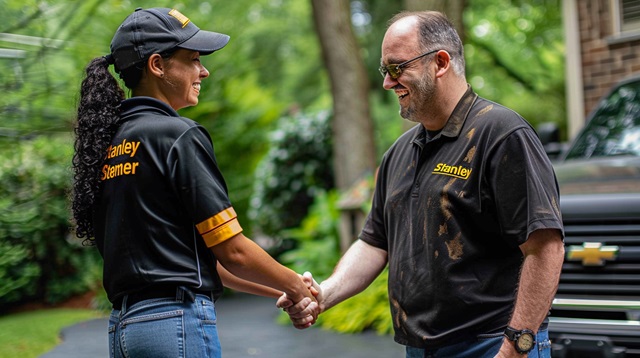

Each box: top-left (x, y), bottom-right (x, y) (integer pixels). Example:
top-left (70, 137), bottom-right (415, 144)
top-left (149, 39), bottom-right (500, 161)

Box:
top-left (72, 57), bottom-right (125, 242)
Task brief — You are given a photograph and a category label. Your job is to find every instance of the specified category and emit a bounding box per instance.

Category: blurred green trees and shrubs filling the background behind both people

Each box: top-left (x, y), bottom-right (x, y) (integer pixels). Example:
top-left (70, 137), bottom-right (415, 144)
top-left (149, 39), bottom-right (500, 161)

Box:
top-left (0, 0), bottom-right (566, 333)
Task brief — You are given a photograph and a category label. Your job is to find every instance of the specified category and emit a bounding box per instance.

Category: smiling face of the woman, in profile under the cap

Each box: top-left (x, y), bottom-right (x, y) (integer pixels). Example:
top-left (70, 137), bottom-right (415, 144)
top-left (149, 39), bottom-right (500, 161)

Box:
top-left (162, 49), bottom-right (209, 111)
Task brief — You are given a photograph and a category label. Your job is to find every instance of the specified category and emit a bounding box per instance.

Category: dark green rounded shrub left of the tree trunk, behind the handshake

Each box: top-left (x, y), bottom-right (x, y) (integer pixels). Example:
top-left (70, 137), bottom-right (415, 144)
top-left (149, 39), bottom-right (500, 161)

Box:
top-left (249, 112), bottom-right (333, 239)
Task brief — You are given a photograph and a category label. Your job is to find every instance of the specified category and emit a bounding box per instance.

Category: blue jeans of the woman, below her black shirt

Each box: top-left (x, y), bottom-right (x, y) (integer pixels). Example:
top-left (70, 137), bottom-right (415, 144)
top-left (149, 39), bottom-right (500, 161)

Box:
top-left (109, 289), bottom-right (222, 358)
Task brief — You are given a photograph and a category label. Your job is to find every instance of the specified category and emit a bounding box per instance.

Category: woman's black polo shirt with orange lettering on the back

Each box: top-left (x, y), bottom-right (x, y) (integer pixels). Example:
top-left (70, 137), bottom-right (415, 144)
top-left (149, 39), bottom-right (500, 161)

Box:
top-left (94, 97), bottom-right (242, 302)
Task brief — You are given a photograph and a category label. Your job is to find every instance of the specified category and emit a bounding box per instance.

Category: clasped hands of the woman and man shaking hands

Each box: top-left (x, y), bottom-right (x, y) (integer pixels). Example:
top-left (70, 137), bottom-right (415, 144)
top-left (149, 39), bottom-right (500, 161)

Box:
top-left (276, 272), bottom-right (327, 329)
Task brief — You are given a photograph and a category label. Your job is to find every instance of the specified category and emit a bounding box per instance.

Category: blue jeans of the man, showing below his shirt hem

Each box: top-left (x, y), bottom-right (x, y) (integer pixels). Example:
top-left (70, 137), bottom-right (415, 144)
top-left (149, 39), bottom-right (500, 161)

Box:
top-left (406, 329), bottom-right (551, 358)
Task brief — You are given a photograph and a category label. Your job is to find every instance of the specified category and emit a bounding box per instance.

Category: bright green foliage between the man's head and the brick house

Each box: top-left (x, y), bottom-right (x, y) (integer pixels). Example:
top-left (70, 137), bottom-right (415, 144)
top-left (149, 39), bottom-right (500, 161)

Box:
top-left (464, 0), bottom-right (566, 133)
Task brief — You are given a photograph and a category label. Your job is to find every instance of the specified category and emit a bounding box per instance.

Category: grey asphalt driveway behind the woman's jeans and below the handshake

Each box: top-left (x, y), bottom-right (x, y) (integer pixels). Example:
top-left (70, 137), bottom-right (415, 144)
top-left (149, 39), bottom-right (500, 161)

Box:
top-left (40, 294), bottom-right (405, 358)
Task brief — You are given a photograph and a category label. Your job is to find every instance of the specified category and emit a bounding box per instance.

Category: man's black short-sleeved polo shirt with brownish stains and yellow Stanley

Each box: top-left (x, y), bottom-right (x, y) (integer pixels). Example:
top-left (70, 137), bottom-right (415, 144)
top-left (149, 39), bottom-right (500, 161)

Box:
top-left (360, 88), bottom-right (562, 348)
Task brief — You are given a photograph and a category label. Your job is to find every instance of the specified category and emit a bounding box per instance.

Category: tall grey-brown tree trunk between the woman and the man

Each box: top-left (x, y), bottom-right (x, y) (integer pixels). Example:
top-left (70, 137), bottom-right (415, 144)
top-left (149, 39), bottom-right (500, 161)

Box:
top-left (311, 0), bottom-right (376, 191)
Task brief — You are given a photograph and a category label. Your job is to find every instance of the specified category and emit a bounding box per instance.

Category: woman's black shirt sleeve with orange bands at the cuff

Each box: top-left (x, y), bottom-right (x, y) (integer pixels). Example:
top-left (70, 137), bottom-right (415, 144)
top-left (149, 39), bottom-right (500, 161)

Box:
top-left (167, 126), bottom-right (242, 247)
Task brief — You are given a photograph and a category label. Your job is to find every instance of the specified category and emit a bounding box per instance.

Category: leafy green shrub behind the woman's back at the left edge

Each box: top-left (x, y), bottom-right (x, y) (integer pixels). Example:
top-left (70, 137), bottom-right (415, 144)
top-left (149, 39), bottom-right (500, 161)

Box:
top-left (0, 135), bottom-right (101, 310)
